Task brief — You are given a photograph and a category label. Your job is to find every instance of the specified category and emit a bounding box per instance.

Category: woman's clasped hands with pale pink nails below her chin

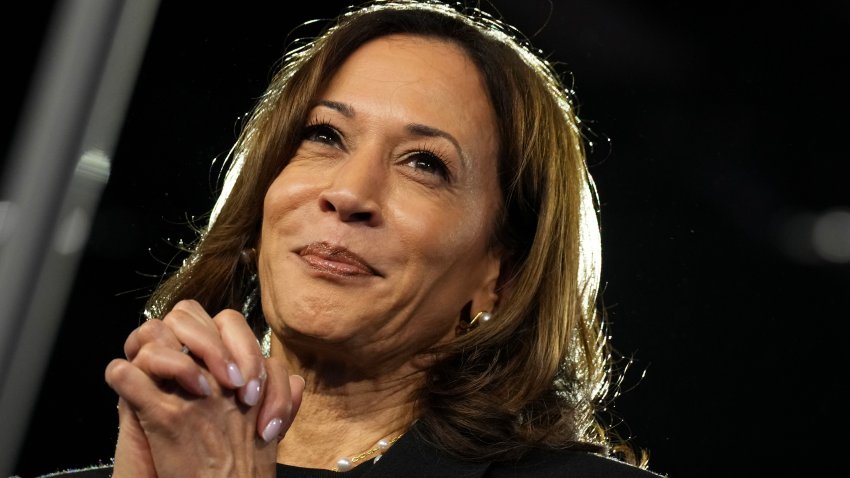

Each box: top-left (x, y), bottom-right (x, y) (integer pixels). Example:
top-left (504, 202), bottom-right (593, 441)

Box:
top-left (105, 300), bottom-right (304, 478)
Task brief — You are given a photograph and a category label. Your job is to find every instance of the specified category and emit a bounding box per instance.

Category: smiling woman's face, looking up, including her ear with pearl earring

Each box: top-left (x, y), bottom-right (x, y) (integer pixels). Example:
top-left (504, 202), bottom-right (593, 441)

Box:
top-left (259, 35), bottom-right (501, 368)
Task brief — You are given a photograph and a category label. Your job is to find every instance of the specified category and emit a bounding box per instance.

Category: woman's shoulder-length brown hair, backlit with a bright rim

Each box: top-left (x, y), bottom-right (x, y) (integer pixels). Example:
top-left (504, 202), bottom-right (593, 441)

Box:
top-left (146, 1), bottom-right (645, 465)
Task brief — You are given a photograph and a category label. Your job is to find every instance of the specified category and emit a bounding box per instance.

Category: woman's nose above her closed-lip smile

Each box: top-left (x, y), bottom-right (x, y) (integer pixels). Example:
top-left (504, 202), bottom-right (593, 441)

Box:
top-left (319, 151), bottom-right (386, 226)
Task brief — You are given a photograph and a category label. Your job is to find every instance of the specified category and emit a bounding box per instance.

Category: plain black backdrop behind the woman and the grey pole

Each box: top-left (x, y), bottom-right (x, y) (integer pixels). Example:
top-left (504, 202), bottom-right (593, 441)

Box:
top-left (3, 0), bottom-right (850, 478)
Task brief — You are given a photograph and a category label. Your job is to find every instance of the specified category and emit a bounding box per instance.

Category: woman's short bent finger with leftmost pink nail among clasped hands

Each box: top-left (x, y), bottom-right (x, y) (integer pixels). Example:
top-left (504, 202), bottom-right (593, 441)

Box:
top-left (131, 343), bottom-right (212, 397)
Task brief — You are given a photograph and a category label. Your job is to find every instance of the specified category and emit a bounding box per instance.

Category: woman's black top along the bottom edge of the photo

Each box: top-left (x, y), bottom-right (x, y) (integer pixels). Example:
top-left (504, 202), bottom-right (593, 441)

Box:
top-left (24, 427), bottom-right (663, 478)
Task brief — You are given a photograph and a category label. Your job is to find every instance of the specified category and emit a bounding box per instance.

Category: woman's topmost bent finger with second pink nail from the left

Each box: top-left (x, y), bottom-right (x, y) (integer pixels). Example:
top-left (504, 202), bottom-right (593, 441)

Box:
top-left (162, 300), bottom-right (245, 389)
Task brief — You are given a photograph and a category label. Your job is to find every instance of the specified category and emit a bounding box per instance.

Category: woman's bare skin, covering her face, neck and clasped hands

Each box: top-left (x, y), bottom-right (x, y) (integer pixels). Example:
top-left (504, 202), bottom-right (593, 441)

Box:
top-left (106, 35), bottom-right (501, 478)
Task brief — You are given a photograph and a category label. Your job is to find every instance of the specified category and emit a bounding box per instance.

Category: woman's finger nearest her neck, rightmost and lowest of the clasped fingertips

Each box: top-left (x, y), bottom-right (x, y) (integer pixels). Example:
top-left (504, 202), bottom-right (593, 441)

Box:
top-left (257, 358), bottom-right (304, 442)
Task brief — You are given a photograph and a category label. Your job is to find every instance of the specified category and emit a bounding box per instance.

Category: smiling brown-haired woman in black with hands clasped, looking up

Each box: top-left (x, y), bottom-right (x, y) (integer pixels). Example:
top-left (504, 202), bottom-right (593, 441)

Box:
top-left (39, 1), bottom-right (655, 477)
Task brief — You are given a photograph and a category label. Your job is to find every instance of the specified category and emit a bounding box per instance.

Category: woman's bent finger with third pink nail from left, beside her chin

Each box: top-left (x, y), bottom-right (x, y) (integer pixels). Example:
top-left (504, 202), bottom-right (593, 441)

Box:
top-left (213, 309), bottom-right (266, 406)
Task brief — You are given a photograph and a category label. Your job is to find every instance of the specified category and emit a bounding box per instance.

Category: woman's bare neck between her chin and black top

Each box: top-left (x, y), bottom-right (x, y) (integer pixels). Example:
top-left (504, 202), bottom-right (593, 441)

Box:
top-left (272, 339), bottom-right (425, 469)
